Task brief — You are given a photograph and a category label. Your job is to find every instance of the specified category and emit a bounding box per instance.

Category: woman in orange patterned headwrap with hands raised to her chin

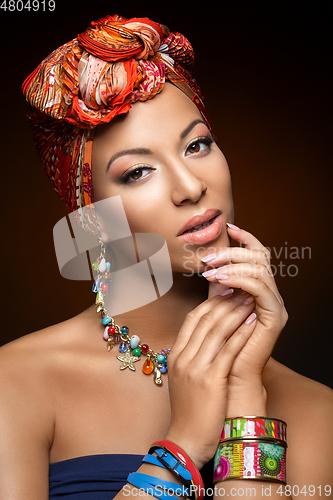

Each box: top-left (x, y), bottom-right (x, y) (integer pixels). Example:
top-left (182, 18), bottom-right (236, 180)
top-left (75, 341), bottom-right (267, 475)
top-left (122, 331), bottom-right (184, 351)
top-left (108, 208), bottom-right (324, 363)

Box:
top-left (1, 13), bottom-right (332, 499)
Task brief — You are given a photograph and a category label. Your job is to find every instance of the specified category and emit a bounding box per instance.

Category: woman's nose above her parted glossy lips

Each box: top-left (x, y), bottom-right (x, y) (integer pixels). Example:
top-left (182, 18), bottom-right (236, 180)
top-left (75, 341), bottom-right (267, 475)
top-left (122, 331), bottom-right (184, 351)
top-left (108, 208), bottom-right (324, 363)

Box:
top-left (172, 161), bottom-right (207, 205)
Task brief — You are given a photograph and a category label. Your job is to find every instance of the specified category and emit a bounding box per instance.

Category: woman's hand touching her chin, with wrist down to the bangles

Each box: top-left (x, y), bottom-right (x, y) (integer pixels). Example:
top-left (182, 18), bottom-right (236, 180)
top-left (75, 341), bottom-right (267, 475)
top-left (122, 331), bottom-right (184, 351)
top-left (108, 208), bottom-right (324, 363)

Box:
top-left (201, 226), bottom-right (288, 417)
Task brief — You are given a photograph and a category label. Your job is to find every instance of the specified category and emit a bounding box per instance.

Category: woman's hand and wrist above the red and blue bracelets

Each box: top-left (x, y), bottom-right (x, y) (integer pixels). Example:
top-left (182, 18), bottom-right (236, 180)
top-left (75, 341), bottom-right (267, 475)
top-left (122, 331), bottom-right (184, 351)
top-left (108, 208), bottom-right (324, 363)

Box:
top-left (166, 294), bottom-right (254, 469)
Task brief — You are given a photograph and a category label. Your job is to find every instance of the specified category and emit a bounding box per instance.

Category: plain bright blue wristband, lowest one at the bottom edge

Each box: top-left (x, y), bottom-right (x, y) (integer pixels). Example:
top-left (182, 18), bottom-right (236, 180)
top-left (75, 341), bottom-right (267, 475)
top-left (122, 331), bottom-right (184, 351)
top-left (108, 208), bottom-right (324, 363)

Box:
top-left (127, 472), bottom-right (189, 500)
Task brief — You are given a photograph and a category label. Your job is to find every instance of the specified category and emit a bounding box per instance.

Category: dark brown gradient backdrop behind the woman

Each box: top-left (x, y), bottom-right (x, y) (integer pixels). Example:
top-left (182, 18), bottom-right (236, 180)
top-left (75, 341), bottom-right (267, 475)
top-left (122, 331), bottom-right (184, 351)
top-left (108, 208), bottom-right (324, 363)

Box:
top-left (0, 0), bottom-right (333, 386)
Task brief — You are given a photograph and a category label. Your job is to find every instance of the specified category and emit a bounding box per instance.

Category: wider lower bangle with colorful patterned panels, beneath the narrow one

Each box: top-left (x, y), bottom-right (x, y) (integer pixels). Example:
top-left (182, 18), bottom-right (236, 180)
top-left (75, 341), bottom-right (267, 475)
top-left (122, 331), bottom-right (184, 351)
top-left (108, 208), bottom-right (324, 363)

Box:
top-left (213, 439), bottom-right (287, 484)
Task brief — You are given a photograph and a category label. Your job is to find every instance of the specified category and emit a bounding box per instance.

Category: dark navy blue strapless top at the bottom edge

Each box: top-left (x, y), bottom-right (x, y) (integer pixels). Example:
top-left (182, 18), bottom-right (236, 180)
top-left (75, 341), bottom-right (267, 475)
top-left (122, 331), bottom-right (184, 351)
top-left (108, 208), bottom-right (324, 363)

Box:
top-left (49, 454), bottom-right (213, 500)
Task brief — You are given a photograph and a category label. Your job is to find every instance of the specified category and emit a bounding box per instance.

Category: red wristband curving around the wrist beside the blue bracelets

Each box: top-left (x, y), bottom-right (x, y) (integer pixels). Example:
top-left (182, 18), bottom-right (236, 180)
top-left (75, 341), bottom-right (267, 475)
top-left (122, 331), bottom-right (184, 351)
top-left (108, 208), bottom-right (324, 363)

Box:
top-left (149, 439), bottom-right (205, 500)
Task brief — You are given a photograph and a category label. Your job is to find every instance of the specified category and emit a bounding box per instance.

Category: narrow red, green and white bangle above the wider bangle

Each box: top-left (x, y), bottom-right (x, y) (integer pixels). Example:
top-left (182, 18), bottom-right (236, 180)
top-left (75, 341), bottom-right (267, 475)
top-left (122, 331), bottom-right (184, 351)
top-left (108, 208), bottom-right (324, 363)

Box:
top-left (221, 417), bottom-right (287, 442)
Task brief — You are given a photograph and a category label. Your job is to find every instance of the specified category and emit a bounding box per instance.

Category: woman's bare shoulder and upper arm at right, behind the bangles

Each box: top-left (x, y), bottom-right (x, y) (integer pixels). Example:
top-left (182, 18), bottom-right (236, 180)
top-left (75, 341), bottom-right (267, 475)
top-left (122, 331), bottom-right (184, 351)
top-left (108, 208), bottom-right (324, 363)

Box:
top-left (264, 359), bottom-right (333, 491)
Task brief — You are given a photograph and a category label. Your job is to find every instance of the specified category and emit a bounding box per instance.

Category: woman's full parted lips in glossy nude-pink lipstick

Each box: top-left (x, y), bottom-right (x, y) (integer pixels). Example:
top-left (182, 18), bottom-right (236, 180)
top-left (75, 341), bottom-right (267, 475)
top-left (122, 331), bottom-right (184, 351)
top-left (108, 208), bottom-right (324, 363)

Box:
top-left (177, 208), bottom-right (222, 245)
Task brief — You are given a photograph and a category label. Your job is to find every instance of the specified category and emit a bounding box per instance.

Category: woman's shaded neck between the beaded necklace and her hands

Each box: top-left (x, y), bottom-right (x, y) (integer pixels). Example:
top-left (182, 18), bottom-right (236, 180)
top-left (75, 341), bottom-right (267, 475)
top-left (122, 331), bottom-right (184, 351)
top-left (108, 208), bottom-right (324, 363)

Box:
top-left (110, 273), bottom-right (208, 351)
